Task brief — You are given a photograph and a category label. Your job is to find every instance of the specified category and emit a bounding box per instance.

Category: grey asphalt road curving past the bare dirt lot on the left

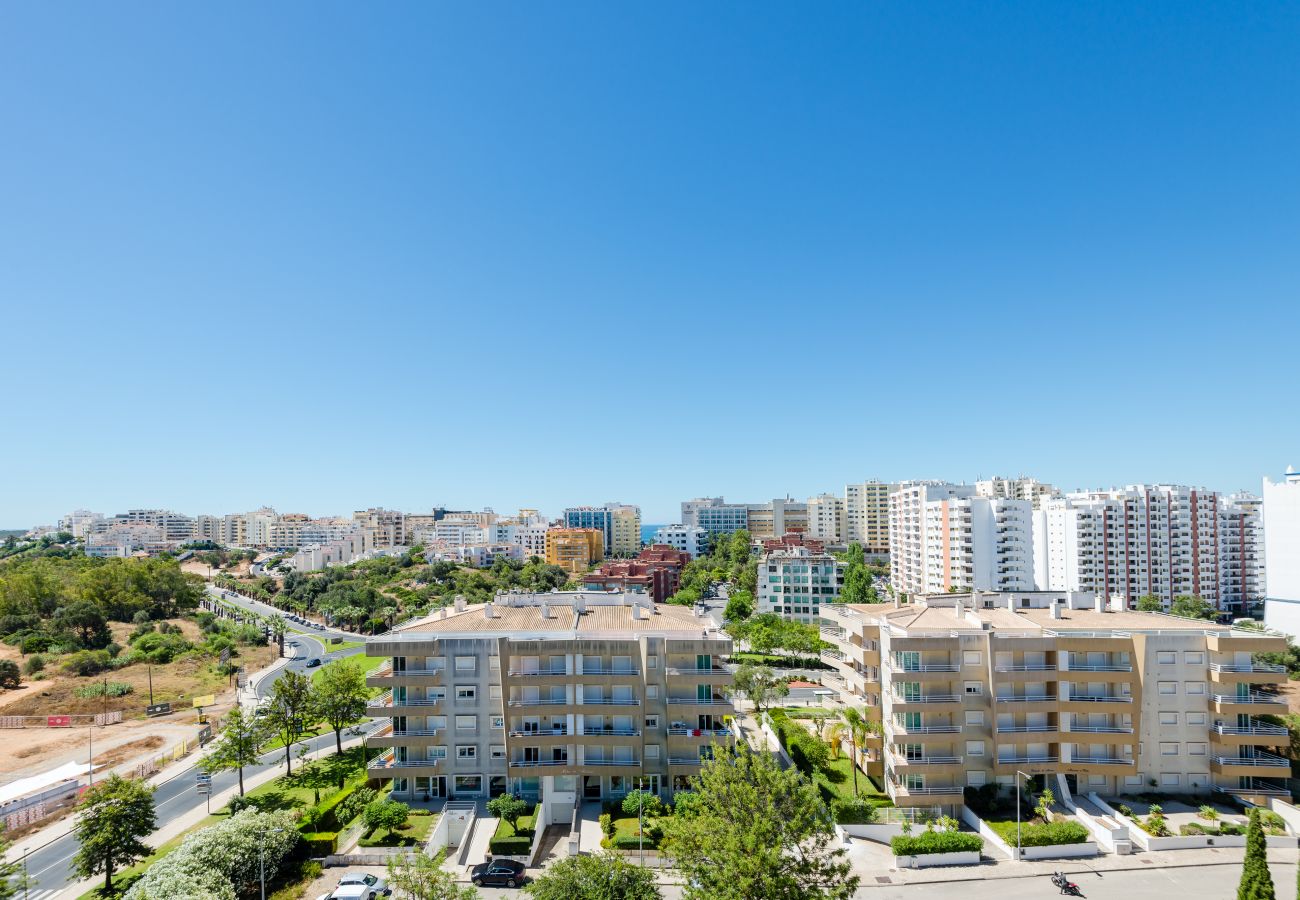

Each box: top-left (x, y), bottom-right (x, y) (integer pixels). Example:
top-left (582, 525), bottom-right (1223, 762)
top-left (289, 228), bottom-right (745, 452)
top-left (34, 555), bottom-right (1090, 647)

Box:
top-left (20, 588), bottom-right (378, 900)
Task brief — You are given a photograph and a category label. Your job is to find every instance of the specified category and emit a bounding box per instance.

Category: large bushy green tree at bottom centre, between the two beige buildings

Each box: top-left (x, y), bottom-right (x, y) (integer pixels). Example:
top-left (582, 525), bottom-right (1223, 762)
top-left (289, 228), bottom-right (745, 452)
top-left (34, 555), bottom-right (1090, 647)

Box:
top-left (667, 747), bottom-right (859, 900)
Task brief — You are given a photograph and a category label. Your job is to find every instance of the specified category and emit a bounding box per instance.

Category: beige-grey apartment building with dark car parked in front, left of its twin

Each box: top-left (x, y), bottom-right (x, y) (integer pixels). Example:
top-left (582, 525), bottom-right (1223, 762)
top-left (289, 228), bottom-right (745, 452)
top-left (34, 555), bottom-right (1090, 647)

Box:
top-left (367, 592), bottom-right (733, 821)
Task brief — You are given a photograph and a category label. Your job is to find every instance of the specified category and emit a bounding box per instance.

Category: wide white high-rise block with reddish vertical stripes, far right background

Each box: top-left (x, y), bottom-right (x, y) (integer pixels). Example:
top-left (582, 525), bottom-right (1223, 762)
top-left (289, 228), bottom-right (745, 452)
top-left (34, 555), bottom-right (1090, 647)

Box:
top-left (1034, 485), bottom-right (1262, 610)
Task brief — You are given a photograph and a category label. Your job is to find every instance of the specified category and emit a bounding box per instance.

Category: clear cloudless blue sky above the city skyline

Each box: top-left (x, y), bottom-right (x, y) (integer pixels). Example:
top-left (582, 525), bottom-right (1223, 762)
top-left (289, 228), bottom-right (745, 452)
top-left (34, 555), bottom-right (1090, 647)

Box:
top-left (0, 0), bottom-right (1300, 527)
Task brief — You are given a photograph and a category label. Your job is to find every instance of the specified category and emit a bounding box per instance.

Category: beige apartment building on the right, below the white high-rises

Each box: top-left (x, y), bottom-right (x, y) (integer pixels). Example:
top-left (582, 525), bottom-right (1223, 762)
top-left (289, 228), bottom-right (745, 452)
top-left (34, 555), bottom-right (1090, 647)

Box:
top-left (822, 592), bottom-right (1291, 808)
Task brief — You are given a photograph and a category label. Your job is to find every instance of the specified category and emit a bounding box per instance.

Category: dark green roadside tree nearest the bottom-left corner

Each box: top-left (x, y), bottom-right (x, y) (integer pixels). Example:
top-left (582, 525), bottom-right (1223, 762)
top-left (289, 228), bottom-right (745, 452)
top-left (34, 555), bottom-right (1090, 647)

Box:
top-left (73, 774), bottom-right (155, 895)
